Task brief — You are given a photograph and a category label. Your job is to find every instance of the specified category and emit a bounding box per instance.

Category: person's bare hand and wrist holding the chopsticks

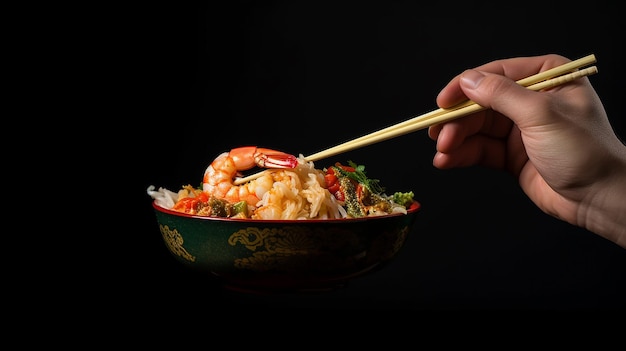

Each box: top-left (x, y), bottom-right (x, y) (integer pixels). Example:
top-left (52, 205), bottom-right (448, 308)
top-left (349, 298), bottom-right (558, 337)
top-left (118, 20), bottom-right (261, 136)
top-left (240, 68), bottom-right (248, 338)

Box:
top-left (428, 55), bottom-right (626, 248)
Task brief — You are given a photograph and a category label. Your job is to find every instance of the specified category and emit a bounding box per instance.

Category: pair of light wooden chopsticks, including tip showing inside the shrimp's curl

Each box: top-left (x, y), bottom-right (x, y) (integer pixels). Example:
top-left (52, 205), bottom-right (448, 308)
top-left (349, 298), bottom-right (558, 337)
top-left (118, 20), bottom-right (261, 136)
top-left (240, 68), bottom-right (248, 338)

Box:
top-left (235, 54), bottom-right (598, 185)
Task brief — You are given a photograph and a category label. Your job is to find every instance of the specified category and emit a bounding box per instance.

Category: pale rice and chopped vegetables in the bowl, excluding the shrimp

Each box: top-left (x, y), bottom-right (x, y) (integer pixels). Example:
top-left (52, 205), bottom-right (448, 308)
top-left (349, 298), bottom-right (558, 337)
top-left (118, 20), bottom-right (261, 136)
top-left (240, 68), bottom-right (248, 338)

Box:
top-left (147, 155), bottom-right (413, 220)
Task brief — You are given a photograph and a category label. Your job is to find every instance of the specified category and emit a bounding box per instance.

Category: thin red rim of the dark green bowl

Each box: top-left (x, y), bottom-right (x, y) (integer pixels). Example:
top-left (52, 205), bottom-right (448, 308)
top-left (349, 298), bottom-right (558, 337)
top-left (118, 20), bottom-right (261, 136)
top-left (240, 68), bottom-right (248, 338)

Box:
top-left (152, 200), bottom-right (422, 224)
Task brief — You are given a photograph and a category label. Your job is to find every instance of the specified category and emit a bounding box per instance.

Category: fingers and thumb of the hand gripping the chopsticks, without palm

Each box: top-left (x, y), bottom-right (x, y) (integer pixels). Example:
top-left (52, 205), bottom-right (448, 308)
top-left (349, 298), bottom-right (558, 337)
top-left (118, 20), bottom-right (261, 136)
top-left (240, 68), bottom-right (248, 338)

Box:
top-left (428, 55), bottom-right (570, 172)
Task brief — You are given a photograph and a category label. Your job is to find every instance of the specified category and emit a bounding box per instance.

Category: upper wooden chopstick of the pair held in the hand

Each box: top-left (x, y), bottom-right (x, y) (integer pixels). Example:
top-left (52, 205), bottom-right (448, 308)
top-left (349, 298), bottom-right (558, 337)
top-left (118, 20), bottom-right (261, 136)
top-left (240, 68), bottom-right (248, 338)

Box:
top-left (305, 54), bottom-right (596, 161)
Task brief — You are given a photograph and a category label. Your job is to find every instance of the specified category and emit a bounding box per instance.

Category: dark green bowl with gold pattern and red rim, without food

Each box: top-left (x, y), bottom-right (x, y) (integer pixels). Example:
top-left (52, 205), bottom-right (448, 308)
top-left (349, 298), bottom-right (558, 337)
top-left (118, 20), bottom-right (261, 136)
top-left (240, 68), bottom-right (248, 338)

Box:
top-left (152, 201), bottom-right (421, 293)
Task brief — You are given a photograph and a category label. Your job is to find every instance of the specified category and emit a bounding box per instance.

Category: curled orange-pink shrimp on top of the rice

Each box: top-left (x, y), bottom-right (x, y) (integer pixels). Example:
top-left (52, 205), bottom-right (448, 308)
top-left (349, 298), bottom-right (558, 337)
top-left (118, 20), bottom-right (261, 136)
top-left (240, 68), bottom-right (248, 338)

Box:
top-left (202, 146), bottom-right (298, 206)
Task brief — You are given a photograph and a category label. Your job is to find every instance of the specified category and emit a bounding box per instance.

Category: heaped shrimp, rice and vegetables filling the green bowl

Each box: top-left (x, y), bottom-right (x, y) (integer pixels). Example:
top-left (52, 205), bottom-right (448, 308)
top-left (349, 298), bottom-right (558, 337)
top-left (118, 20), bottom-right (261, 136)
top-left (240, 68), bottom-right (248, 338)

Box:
top-left (148, 147), bottom-right (414, 220)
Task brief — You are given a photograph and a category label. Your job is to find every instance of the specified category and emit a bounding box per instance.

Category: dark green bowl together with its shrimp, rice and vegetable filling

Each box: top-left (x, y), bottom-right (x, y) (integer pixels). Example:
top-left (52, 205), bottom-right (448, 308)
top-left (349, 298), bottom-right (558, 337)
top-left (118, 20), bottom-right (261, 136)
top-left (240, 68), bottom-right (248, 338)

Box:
top-left (148, 148), bottom-right (420, 292)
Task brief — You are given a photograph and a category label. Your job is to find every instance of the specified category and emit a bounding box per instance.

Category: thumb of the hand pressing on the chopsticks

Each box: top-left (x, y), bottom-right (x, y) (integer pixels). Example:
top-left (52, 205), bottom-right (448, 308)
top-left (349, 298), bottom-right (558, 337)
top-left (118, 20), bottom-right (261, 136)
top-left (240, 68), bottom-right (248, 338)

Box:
top-left (459, 69), bottom-right (542, 126)
